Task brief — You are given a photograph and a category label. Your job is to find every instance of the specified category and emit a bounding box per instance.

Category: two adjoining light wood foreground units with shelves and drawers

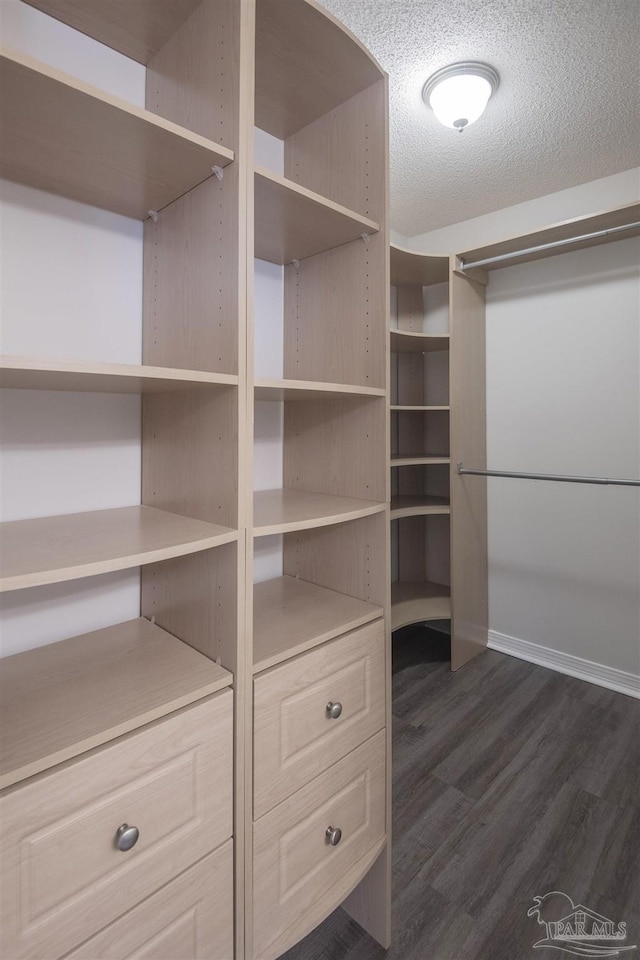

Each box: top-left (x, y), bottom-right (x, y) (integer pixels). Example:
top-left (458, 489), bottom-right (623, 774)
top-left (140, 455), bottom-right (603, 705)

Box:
top-left (0, 0), bottom-right (390, 960)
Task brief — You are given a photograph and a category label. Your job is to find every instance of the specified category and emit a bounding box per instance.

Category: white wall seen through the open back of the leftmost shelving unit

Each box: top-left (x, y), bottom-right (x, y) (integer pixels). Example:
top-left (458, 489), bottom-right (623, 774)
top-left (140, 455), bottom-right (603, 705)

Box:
top-left (0, 0), bottom-right (144, 655)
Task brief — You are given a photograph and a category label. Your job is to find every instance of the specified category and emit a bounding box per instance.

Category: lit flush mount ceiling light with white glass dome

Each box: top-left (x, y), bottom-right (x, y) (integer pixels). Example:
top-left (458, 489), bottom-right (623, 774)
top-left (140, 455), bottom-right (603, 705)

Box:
top-left (422, 61), bottom-right (500, 133)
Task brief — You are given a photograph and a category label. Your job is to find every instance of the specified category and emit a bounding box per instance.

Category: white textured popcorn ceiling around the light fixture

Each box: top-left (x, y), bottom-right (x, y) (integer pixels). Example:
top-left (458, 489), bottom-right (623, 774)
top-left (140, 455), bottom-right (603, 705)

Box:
top-left (322, 0), bottom-right (640, 237)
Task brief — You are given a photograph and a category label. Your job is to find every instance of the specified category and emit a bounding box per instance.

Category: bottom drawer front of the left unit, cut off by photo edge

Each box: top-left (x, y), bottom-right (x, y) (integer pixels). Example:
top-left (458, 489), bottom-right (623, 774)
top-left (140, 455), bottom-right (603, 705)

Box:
top-left (65, 840), bottom-right (233, 960)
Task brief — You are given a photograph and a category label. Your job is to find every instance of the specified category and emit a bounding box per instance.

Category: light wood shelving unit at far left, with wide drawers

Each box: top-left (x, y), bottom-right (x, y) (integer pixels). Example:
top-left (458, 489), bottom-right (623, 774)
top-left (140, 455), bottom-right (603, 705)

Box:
top-left (0, 0), bottom-right (246, 960)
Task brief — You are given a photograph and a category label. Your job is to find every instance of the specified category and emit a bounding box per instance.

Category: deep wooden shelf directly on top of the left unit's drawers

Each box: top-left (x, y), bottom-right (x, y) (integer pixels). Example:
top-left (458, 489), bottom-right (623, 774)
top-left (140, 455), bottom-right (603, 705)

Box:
top-left (0, 618), bottom-right (233, 787)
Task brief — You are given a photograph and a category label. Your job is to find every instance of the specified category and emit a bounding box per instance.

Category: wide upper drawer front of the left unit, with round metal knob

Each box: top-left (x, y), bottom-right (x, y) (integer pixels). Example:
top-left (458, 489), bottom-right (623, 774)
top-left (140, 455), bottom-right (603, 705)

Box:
top-left (0, 690), bottom-right (233, 960)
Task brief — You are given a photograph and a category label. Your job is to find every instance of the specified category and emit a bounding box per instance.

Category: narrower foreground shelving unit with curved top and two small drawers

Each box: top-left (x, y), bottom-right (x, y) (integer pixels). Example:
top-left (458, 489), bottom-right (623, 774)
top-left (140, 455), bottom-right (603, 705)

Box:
top-left (245, 0), bottom-right (390, 960)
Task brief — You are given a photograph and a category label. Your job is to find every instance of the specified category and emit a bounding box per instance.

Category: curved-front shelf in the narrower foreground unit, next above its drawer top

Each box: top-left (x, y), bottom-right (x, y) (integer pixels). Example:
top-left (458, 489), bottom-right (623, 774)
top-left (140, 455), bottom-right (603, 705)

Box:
top-left (253, 489), bottom-right (386, 537)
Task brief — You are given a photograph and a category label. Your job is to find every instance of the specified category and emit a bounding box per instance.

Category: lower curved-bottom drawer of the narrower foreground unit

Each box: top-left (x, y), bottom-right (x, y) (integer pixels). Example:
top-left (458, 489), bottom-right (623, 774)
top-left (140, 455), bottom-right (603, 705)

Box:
top-left (253, 730), bottom-right (386, 960)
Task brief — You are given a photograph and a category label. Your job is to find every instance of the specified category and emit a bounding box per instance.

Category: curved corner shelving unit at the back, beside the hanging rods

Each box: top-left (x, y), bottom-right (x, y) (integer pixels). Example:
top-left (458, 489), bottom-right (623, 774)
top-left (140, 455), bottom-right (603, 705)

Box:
top-left (390, 246), bottom-right (486, 670)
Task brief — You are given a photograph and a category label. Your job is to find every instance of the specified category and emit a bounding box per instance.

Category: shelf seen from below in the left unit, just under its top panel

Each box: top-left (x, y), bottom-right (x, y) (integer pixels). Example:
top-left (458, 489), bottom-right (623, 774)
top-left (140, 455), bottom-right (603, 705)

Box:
top-left (0, 50), bottom-right (233, 220)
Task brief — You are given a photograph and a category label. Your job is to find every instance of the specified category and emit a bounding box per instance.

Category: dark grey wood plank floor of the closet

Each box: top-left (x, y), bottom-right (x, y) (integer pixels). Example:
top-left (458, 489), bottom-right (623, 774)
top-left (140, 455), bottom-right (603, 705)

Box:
top-left (284, 629), bottom-right (640, 960)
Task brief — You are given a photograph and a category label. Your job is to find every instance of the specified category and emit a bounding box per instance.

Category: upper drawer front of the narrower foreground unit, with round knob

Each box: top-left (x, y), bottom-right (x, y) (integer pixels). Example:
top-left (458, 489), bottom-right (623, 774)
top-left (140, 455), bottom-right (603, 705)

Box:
top-left (253, 620), bottom-right (385, 820)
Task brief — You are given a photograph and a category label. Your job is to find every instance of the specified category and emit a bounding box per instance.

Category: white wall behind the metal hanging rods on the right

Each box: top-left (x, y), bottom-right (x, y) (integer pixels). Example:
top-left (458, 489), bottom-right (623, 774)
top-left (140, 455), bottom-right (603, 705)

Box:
top-left (403, 170), bottom-right (640, 688)
